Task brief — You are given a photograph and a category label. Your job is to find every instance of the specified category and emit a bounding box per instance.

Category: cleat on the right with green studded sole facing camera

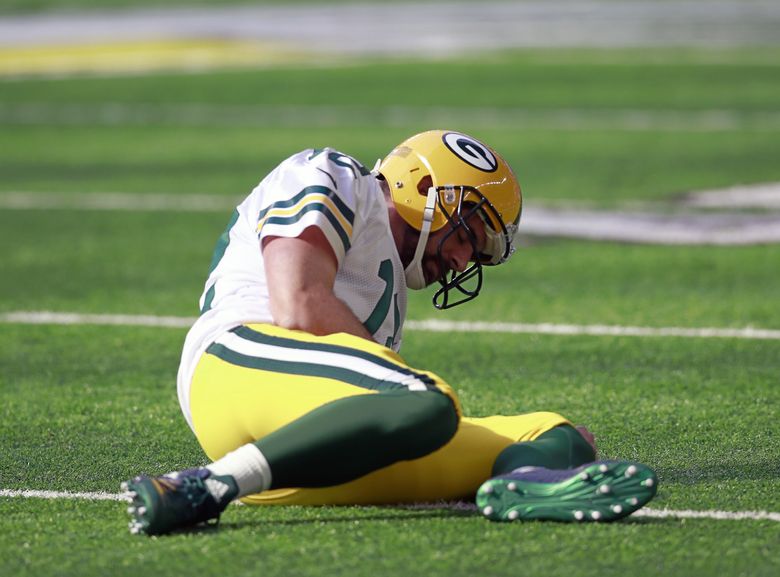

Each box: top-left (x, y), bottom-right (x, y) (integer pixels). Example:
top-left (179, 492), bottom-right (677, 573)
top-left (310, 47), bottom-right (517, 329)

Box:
top-left (477, 461), bottom-right (658, 521)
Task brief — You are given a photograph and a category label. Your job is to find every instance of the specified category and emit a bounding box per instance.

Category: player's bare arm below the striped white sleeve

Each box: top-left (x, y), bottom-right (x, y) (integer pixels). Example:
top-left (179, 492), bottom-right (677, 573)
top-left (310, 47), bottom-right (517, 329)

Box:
top-left (261, 226), bottom-right (372, 340)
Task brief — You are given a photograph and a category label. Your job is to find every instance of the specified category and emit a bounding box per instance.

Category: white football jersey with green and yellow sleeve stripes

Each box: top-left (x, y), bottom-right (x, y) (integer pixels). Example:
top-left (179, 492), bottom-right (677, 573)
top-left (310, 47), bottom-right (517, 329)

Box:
top-left (178, 148), bottom-right (406, 427)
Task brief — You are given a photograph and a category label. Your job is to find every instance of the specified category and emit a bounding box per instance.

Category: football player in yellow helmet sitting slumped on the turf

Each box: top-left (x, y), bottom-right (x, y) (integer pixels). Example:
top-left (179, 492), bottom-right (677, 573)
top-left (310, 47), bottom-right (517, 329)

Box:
top-left (122, 130), bottom-right (657, 535)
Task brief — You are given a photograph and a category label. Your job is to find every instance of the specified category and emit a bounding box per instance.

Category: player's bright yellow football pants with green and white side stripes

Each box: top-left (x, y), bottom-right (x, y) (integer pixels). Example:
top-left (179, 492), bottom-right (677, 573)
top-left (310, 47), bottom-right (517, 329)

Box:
top-left (190, 325), bottom-right (571, 505)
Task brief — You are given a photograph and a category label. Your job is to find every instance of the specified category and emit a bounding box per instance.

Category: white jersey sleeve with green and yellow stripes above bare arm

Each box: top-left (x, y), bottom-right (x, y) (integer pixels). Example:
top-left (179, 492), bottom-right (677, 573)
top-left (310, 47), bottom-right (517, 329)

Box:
top-left (257, 149), bottom-right (361, 265)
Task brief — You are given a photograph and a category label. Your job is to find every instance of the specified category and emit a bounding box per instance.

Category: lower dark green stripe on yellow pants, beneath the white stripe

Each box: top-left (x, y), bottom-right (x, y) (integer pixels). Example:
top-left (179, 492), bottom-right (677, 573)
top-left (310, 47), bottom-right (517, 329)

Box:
top-left (206, 343), bottom-right (414, 391)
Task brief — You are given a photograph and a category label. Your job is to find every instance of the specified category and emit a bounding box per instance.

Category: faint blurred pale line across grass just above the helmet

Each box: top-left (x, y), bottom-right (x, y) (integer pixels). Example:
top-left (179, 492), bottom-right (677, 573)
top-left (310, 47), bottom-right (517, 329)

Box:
top-left (0, 102), bottom-right (780, 132)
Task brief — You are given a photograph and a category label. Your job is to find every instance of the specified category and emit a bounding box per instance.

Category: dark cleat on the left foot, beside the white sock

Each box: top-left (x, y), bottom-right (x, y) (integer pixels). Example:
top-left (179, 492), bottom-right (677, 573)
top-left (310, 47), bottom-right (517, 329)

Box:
top-left (120, 467), bottom-right (238, 535)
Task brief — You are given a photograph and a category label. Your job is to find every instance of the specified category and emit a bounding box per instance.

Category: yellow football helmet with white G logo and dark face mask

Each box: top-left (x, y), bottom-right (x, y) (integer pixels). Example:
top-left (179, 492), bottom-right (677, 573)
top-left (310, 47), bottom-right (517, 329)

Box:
top-left (378, 130), bottom-right (522, 308)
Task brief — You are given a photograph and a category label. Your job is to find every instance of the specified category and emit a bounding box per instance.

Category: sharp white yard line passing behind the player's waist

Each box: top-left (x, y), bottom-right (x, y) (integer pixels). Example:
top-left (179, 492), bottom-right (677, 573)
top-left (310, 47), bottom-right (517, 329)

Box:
top-left (0, 311), bottom-right (780, 340)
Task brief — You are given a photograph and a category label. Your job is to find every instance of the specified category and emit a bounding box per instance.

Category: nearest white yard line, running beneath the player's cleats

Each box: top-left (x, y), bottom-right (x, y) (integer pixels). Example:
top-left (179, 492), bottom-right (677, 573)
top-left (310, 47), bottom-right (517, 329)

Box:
top-left (0, 489), bottom-right (780, 522)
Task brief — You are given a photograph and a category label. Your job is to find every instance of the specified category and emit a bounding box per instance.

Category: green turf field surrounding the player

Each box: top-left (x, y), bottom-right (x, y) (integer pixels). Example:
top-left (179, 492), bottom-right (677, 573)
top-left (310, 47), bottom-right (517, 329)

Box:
top-left (0, 39), bottom-right (780, 577)
